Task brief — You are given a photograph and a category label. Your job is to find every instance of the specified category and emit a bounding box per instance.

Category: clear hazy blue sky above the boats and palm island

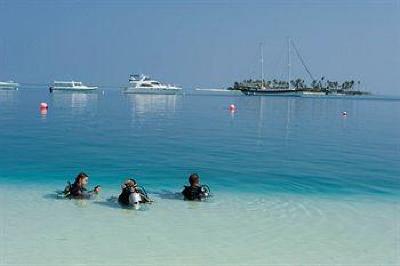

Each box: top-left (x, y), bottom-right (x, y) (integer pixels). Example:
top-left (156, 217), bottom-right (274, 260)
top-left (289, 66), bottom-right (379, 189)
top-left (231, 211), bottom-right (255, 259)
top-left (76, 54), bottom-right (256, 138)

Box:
top-left (0, 0), bottom-right (400, 95)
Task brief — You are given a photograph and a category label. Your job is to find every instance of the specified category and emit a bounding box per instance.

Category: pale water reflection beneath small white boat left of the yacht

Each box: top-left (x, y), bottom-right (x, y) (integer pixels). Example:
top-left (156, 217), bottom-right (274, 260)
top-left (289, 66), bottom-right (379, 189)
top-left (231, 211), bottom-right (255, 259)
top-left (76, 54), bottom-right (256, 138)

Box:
top-left (51, 92), bottom-right (98, 112)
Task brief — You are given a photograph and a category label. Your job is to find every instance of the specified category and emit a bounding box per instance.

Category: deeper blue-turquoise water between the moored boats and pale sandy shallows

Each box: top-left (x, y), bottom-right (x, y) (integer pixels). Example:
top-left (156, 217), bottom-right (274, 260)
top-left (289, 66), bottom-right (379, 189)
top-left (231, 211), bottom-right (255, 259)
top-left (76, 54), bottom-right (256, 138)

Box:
top-left (0, 90), bottom-right (400, 195)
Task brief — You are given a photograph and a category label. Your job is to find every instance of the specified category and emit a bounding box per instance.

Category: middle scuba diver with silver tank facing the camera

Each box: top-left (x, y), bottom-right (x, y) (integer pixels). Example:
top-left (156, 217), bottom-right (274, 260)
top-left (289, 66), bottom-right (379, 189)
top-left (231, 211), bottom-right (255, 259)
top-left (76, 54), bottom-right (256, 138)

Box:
top-left (118, 178), bottom-right (153, 209)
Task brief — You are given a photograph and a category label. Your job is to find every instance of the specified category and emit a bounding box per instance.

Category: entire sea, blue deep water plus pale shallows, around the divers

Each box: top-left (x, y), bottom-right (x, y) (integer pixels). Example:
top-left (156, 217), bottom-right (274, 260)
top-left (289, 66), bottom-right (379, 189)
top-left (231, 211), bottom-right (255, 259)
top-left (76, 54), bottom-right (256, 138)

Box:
top-left (0, 88), bottom-right (400, 265)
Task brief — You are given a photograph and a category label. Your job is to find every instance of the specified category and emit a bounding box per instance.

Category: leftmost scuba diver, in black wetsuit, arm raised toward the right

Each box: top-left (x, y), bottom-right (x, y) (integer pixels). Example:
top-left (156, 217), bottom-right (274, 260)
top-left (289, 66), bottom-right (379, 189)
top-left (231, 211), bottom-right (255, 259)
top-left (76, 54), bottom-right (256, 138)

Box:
top-left (63, 172), bottom-right (101, 199)
